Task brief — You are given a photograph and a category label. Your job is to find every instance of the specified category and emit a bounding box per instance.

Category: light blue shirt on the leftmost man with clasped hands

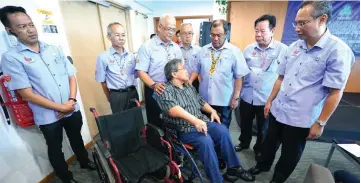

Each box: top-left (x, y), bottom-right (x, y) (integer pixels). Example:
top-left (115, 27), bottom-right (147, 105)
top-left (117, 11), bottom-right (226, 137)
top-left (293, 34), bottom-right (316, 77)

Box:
top-left (1, 41), bottom-right (79, 125)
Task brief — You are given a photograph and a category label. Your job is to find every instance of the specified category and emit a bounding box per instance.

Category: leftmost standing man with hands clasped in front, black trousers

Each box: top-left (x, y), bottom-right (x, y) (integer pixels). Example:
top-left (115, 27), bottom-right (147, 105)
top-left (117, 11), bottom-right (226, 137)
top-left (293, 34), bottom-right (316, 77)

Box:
top-left (0, 6), bottom-right (95, 183)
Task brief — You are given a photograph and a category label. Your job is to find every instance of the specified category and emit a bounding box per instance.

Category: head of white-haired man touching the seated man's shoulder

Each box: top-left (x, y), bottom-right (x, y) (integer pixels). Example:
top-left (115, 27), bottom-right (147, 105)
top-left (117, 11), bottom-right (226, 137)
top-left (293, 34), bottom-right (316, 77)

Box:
top-left (157, 14), bottom-right (176, 43)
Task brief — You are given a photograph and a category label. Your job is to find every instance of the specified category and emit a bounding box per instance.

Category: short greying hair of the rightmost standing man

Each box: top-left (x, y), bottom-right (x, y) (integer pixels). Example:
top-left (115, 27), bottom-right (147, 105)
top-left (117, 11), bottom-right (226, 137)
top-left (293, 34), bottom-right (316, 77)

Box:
top-left (298, 1), bottom-right (332, 22)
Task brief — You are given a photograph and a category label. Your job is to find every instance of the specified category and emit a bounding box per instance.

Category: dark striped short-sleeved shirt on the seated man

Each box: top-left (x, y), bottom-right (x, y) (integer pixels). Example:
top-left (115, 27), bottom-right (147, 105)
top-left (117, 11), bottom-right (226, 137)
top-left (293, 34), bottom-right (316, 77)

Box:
top-left (156, 82), bottom-right (209, 135)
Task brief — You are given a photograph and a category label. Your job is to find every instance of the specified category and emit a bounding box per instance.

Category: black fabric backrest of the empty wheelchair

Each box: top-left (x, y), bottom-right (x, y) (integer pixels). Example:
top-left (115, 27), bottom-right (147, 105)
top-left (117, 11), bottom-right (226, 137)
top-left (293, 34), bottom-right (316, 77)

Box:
top-left (97, 107), bottom-right (145, 158)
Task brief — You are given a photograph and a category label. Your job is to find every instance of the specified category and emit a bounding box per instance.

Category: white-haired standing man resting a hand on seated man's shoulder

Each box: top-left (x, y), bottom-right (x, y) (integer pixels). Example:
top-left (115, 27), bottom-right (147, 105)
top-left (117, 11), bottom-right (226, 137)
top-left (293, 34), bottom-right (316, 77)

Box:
top-left (135, 15), bottom-right (182, 126)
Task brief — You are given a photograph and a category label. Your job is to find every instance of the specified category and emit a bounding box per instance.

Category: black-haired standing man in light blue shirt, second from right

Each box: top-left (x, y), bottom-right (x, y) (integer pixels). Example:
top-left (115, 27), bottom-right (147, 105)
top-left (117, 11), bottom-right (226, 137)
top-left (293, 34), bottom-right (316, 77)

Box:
top-left (235, 15), bottom-right (287, 157)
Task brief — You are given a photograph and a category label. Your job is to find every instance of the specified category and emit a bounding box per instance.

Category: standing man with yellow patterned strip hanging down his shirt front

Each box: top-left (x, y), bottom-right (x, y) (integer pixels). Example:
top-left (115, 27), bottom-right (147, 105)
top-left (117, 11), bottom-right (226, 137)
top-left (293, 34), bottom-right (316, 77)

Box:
top-left (190, 20), bottom-right (250, 128)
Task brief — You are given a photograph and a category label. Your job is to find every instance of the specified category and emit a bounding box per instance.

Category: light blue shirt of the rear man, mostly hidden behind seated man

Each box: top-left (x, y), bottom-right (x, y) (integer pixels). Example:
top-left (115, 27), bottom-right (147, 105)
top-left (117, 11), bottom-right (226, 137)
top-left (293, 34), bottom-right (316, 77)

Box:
top-left (179, 44), bottom-right (201, 75)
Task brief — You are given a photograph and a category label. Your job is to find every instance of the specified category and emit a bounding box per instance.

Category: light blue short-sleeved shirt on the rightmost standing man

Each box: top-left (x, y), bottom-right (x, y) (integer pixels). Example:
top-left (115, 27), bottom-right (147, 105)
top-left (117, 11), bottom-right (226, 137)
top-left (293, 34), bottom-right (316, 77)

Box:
top-left (271, 30), bottom-right (355, 128)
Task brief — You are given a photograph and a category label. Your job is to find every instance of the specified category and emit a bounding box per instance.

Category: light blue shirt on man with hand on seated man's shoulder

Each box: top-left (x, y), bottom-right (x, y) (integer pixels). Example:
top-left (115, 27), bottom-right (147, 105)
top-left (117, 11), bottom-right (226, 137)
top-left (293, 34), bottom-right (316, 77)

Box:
top-left (135, 35), bottom-right (183, 83)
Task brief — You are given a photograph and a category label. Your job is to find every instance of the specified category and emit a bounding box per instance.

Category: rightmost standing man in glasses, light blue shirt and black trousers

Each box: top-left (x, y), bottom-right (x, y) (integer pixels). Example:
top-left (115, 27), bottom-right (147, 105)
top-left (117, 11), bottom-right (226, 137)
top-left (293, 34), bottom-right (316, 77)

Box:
top-left (249, 1), bottom-right (355, 183)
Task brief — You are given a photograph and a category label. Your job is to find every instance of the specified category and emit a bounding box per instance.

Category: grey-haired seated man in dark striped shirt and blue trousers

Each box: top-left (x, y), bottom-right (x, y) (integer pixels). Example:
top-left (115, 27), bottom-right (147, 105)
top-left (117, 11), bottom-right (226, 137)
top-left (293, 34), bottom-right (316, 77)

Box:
top-left (155, 59), bottom-right (255, 183)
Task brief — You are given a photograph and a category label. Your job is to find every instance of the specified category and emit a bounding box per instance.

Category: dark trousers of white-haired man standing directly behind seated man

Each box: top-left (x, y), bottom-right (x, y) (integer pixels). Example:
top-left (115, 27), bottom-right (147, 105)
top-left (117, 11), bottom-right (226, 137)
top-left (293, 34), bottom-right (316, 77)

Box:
top-left (144, 86), bottom-right (163, 128)
